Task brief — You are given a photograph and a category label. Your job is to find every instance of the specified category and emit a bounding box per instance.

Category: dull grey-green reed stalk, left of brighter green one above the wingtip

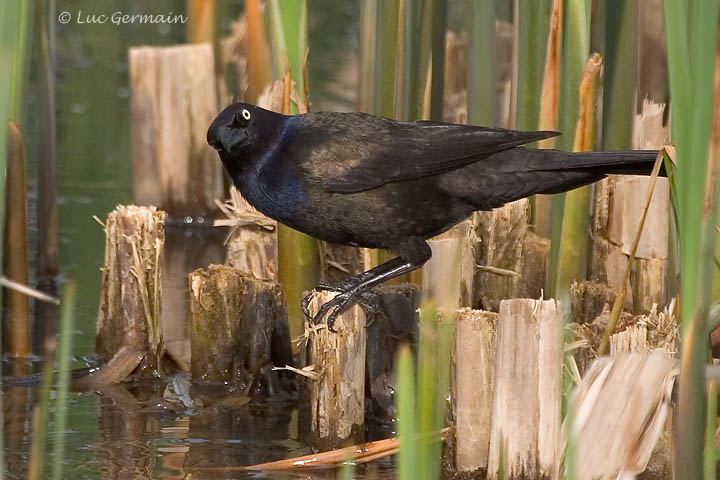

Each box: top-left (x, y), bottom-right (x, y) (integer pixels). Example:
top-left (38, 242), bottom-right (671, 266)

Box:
top-left (467, 0), bottom-right (498, 125)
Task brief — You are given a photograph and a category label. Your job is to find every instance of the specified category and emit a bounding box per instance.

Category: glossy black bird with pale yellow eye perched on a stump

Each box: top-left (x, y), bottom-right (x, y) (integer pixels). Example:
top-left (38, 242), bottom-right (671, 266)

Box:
top-left (207, 103), bottom-right (657, 328)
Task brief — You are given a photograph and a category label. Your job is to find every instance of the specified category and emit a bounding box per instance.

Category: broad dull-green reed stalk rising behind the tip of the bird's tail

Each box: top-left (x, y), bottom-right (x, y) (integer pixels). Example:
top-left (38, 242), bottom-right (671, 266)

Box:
top-left (602, 0), bottom-right (638, 150)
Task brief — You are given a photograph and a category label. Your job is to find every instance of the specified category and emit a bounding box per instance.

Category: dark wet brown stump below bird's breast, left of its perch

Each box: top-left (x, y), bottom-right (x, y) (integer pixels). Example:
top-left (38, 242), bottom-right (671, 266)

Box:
top-left (189, 265), bottom-right (293, 397)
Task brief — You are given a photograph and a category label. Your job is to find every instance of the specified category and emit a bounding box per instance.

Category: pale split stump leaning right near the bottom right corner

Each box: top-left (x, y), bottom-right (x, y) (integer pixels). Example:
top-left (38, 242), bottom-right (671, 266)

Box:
top-left (561, 353), bottom-right (677, 480)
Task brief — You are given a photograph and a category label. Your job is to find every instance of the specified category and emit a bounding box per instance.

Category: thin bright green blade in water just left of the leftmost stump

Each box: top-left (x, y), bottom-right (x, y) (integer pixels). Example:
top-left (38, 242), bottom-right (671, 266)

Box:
top-left (52, 282), bottom-right (75, 480)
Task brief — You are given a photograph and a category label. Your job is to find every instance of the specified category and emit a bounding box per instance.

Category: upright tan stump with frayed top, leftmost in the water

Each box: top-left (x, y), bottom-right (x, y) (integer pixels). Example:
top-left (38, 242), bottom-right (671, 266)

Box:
top-left (96, 205), bottom-right (166, 375)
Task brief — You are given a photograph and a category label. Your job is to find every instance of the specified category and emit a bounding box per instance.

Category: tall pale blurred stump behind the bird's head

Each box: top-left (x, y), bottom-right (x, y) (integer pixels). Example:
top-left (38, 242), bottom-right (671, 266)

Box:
top-left (129, 43), bottom-right (223, 217)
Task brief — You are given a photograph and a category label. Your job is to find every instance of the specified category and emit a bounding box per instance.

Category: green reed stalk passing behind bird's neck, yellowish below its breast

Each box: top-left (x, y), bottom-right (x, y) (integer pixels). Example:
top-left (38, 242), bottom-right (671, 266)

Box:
top-left (268, 0), bottom-right (320, 338)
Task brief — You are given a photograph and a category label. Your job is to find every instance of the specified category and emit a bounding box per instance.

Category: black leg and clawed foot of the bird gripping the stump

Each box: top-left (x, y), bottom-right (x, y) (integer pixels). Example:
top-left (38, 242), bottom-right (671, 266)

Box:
top-left (302, 239), bottom-right (432, 330)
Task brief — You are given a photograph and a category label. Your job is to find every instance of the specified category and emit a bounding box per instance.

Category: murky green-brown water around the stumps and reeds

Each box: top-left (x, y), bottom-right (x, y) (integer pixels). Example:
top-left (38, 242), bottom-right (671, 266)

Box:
top-left (3, 0), bottom-right (392, 479)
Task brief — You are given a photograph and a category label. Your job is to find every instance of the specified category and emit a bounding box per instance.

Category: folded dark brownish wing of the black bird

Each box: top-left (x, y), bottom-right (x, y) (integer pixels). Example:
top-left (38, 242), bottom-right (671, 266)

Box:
top-left (302, 116), bottom-right (558, 193)
